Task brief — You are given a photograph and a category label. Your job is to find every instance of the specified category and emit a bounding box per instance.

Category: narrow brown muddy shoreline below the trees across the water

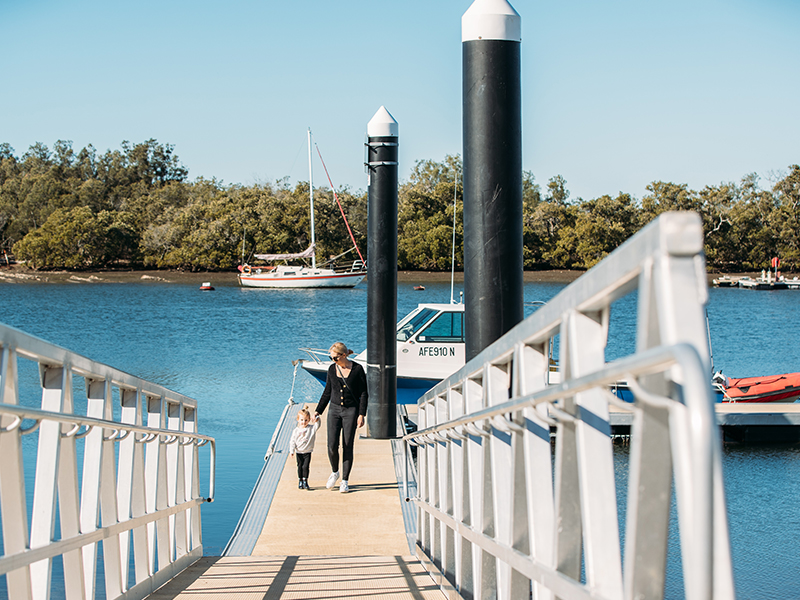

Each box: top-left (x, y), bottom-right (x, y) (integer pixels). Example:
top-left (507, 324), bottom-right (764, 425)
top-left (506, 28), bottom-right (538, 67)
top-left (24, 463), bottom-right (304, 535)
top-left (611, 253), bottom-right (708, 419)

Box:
top-left (0, 265), bottom-right (788, 286)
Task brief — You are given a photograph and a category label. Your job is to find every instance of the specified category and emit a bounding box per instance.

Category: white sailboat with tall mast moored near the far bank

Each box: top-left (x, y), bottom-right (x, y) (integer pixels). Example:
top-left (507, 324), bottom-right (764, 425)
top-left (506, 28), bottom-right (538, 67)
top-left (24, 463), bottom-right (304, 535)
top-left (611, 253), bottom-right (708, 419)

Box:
top-left (238, 128), bottom-right (367, 289)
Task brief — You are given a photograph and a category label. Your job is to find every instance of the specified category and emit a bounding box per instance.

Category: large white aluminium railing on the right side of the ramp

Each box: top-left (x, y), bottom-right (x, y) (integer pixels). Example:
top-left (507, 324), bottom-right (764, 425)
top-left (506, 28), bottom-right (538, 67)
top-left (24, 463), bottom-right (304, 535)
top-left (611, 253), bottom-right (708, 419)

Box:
top-left (405, 213), bottom-right (734, 600)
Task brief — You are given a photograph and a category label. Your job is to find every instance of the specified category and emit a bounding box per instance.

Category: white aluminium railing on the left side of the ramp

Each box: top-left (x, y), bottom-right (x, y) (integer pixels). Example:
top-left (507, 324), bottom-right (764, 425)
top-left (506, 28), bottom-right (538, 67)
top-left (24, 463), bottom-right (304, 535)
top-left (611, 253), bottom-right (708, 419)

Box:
top-left (0, 325), bottom-right (215, 600)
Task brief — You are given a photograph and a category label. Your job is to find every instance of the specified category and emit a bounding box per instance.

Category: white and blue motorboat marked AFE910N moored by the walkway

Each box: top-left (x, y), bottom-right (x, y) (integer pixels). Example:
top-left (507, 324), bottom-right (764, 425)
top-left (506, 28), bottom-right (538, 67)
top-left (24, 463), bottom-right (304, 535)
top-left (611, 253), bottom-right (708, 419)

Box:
top-left (300, 303), bottom-right (466, 404)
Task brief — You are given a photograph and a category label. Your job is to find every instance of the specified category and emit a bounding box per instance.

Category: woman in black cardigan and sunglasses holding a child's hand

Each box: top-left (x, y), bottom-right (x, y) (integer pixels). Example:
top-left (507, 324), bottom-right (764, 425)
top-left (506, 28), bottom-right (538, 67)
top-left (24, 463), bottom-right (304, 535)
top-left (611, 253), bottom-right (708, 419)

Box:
top-left (315, 342), bottom-right (367, 492)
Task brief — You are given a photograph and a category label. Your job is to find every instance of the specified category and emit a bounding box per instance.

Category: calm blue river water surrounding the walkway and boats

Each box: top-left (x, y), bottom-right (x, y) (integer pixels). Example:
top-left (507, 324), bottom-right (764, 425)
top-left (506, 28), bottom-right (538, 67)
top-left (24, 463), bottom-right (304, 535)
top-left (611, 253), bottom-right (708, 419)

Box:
top-left (0, 275), bottom-right (800, 598)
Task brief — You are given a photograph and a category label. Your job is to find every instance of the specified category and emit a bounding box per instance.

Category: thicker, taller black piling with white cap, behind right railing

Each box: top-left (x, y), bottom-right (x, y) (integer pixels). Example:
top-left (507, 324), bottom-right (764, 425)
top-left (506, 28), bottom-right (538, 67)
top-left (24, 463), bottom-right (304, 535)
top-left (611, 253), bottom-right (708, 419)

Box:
top-left (461, 0), bottom-right (523, 360)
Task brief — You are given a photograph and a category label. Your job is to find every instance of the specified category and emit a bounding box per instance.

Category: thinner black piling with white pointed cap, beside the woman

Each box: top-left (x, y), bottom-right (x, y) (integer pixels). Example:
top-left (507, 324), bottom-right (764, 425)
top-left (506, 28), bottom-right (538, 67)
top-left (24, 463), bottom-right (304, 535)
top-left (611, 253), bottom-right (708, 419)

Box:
top-left (366, 106), bottom-right (398, 439)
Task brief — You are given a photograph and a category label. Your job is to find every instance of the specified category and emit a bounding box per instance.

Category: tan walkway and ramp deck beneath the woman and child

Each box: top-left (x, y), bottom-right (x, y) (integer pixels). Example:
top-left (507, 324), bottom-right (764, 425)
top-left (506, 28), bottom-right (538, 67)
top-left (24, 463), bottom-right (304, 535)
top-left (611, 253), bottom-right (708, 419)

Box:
top-left (150, 405), bottom-right (445, 600)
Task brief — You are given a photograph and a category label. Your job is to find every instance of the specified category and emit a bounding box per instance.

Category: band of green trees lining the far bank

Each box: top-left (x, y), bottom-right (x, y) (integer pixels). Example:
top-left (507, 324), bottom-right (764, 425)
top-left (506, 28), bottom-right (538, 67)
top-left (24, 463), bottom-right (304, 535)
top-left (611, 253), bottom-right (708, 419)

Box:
top-left (0, 139), bottom-right (800, 271)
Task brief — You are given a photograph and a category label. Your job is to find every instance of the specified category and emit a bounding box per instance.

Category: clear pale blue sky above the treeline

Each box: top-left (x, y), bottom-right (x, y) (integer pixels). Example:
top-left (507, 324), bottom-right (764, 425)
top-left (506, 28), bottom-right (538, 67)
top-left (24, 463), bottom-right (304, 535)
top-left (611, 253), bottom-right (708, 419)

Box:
top-left (0, 0), bottom-right (800, 199)
